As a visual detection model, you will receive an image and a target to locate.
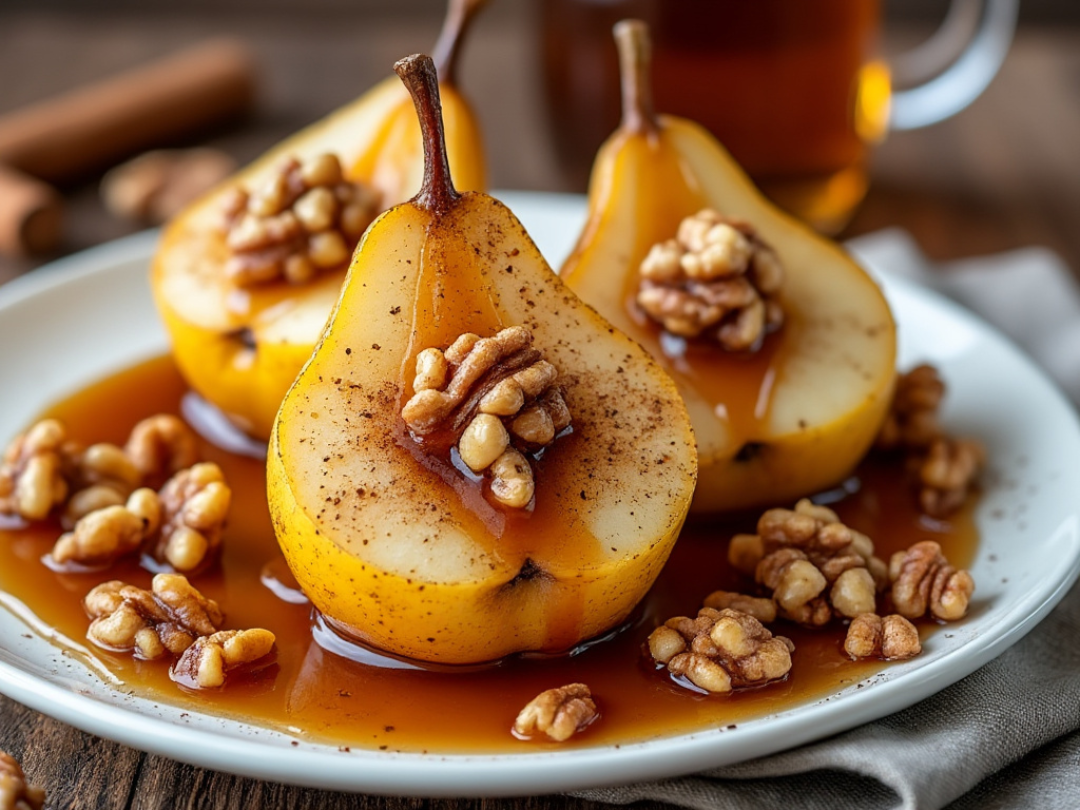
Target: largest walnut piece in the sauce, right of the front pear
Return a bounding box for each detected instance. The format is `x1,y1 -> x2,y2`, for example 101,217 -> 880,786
728,498 -> 889,626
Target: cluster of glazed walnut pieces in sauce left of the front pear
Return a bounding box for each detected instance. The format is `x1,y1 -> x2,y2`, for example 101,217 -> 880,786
0,414 -> 274,688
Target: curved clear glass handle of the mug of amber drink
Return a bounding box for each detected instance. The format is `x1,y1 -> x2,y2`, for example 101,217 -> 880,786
889,0 -> 1020,131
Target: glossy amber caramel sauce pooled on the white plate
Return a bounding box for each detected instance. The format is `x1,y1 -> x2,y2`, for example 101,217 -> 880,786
0,357 -> 977,753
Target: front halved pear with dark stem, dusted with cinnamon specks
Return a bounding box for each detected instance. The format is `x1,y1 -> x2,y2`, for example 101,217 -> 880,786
267,56 -> 697,664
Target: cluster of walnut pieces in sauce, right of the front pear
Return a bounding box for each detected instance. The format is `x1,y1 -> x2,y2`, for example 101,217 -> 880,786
630,499 -> 975,708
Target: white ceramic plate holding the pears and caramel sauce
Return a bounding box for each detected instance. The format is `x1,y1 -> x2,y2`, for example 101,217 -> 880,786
0,193 -> 1080,796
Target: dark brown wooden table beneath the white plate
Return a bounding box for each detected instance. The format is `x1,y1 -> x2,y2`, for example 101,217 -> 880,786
0,3 -> 1080,809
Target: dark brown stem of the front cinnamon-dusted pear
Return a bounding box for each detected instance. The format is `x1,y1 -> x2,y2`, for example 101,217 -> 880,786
394,53 -> 461,214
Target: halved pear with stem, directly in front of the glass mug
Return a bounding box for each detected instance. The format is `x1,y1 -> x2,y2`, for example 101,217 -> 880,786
559,21 -> 896,512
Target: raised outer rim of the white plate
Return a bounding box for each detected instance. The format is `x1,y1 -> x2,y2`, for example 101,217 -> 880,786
0,191 -> 1080,797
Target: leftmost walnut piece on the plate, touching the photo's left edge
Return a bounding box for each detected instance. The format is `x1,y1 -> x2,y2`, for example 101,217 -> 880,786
0,419 -> 69,521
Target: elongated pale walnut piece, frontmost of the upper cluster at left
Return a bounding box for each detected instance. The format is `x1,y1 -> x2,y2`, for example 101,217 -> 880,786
50,489 -> 161,566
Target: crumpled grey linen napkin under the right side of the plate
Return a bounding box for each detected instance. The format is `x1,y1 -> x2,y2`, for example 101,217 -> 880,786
575,230 -> 1080,810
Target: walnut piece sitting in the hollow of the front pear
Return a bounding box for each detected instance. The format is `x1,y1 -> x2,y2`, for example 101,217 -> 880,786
402,326 -> 570,509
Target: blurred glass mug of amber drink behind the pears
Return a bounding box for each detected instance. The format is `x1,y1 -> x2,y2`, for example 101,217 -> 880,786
540,0 -> 1018,233
